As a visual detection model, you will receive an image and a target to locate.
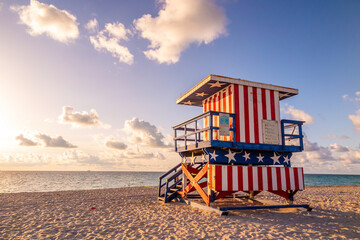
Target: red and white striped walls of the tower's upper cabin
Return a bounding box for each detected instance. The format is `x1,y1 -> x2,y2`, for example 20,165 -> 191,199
203,84 -> 281,144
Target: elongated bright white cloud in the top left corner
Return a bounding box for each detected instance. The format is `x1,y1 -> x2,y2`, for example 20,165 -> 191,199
10,0 -> 79,43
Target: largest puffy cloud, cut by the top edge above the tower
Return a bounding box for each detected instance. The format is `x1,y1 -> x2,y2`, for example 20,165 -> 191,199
134,0 -> 227,64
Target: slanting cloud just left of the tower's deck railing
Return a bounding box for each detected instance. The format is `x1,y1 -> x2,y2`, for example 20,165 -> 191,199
125,117 -> 172,148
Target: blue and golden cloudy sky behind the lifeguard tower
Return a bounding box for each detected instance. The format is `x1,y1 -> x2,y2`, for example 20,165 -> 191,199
0,0 -> 360,174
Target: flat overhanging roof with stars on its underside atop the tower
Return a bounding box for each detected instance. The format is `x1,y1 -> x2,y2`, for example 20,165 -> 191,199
176,74 -> 299,107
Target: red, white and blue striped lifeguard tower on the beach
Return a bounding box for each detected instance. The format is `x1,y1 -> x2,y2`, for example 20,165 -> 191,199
159,75 -> 309,214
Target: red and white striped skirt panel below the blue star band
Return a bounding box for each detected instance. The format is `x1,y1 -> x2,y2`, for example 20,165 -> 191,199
208,164 -> 305,191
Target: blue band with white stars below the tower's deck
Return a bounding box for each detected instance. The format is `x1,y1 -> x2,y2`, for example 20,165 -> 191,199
204,148 -> 292,166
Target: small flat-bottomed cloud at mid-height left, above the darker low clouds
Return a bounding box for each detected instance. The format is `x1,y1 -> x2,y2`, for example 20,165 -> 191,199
59,106 -> 110,128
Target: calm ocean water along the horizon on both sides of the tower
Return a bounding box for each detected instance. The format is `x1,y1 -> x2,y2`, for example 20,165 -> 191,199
0,171 -> 360,193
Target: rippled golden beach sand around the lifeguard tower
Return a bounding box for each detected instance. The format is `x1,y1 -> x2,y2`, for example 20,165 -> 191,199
0,186 -> 360,239
